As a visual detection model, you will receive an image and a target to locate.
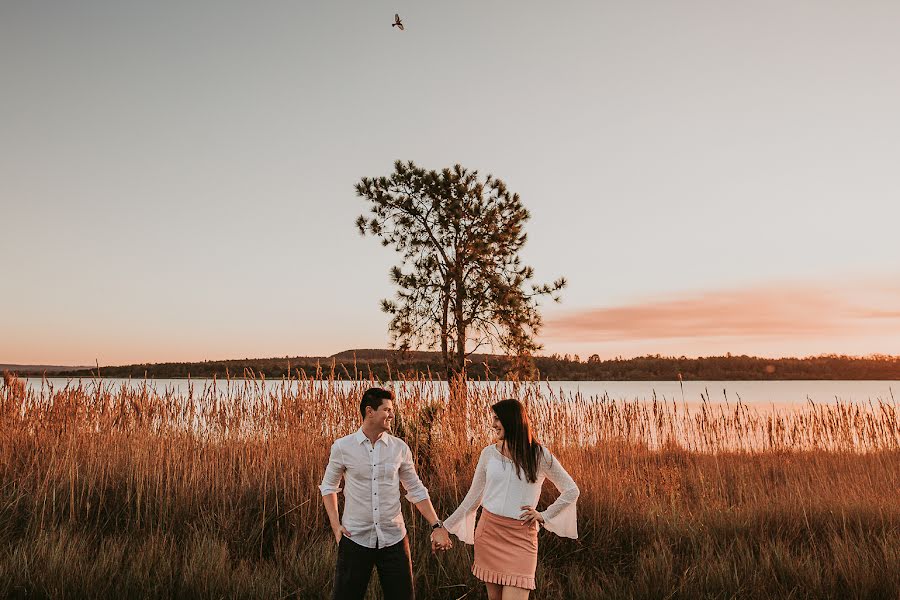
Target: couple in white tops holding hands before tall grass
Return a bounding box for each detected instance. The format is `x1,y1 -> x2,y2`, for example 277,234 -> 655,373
319,388 -> 579,600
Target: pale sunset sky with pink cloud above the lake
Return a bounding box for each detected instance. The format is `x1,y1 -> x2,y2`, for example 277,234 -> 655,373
0,0 -> 900,365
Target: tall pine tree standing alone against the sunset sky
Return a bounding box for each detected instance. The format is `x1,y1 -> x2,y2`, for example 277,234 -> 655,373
356,161 -> 566,379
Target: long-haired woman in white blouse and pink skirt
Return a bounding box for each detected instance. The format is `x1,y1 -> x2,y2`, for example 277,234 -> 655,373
444,400 -> 579,600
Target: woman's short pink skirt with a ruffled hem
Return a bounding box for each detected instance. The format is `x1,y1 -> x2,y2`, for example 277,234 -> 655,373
472,508 -> 538,590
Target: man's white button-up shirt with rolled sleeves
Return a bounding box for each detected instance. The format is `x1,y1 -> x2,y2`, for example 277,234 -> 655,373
319,429 -> 428,548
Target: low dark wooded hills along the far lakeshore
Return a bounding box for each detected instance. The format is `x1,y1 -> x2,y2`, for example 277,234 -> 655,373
11,349 -> 900,381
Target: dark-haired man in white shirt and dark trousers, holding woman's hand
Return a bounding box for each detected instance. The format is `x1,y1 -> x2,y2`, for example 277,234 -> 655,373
319,388 -> 452,600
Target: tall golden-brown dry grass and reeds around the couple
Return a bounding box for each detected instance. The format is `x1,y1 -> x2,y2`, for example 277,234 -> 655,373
0,378 -> 900,600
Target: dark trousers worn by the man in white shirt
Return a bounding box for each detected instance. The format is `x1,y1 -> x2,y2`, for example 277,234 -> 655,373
332,537 -> 416,600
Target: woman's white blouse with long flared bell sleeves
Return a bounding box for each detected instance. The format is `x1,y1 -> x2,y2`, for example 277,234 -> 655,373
444,444 -> 579,544
